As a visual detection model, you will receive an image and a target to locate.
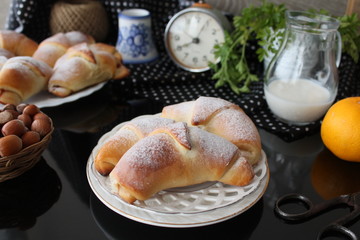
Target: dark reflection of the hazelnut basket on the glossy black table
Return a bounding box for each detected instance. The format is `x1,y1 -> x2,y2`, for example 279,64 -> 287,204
0,159 -> 61,230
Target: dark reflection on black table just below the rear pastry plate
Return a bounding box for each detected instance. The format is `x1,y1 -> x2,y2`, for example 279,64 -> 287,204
42,83 -> 163,133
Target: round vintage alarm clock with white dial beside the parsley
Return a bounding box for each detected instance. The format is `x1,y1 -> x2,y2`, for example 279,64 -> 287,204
164,2 -> 231,72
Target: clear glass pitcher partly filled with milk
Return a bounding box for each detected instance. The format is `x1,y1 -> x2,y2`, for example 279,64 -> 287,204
264,11 -> 341,125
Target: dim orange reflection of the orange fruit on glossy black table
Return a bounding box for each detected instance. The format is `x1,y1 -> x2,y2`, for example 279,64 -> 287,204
311,149 -> 360,200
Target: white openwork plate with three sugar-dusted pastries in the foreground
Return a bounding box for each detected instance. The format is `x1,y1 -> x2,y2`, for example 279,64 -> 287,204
87,97 -> 269,228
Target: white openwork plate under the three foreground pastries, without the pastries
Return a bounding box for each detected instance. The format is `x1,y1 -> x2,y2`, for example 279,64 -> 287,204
87,116 -> 269,227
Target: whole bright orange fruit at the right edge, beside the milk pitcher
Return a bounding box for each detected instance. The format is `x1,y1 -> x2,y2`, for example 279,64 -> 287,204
321,97 -> 360,162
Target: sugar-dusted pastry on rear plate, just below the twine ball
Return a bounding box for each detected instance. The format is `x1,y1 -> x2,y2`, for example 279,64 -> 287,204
33,31 -> 95,67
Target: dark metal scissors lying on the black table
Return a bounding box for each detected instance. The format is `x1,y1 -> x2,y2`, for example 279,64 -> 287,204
274,192 -> 360,240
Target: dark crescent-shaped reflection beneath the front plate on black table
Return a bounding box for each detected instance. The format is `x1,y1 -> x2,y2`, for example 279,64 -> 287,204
90,194 -> 263,240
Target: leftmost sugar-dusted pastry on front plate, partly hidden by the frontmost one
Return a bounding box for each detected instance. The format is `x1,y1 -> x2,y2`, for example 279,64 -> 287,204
94,117 -> 175,175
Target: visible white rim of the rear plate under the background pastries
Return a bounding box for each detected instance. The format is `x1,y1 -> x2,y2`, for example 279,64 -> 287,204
25,82 -> 106,108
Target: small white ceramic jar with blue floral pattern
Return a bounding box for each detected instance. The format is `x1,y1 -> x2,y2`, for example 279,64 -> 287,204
116,8 -> 158,64
